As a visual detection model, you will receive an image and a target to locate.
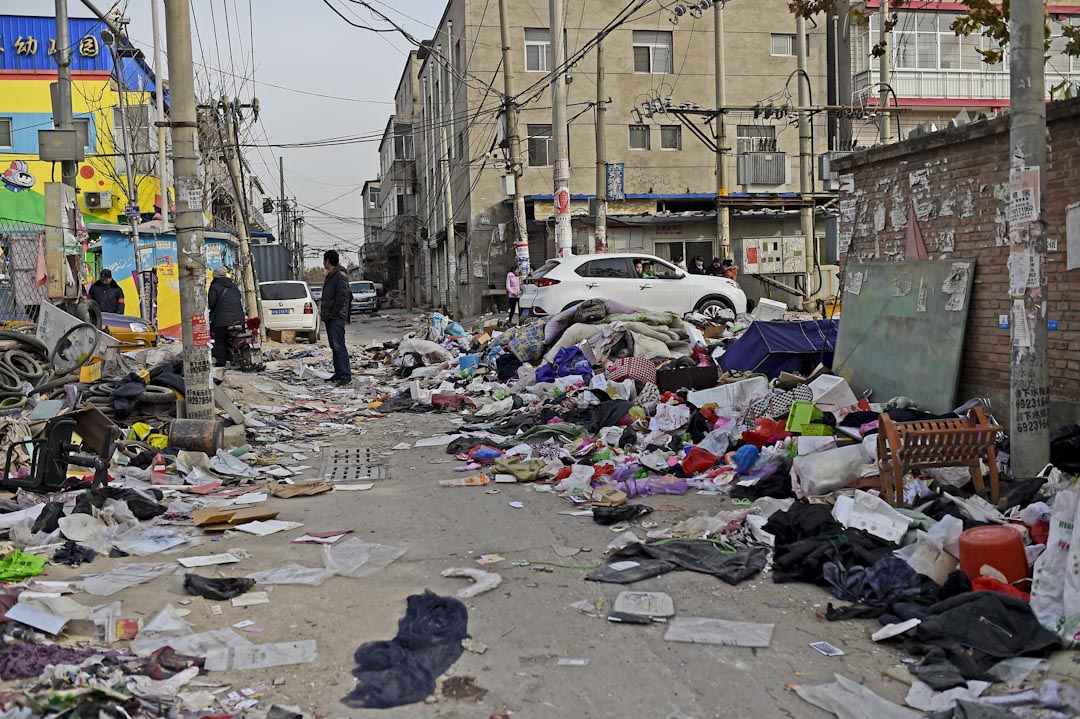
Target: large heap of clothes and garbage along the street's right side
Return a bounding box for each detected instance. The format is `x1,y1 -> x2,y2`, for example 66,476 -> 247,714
367,300 -> 1080,717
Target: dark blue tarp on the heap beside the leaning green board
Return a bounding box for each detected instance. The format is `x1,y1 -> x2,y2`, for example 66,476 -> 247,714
720,320 -> 840,379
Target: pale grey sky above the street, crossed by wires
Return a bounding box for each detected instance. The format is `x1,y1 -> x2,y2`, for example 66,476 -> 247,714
13,0 -> 445,264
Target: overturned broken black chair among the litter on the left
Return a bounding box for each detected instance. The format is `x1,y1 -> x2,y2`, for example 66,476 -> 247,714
0,415 -> 121,492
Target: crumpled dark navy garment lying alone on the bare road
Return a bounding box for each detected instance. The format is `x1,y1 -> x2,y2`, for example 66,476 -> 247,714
341,592 -> 469,709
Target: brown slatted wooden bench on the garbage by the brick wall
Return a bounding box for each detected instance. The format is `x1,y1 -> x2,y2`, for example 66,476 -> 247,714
878,407 -> 1001,506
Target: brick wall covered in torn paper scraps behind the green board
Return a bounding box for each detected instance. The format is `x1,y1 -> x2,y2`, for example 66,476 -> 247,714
837,99 -> 1080,430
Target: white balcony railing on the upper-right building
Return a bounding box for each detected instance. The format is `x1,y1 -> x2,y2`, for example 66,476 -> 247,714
852,67 -> 1080,105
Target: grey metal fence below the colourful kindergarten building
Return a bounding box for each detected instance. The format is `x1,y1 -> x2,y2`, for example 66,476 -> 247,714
0,219 -> 48,324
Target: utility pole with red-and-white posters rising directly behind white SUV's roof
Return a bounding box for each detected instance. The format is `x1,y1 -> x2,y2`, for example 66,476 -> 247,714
550,0 -> 573,257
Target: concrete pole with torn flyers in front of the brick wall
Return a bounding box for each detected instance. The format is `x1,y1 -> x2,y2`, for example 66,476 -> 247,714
1007,0 -> 1050,478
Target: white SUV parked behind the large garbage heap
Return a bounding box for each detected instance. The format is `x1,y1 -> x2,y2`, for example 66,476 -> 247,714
519,253 -> 748,316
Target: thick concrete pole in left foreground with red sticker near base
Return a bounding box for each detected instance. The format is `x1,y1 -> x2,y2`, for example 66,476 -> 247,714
165,0 -> 214,419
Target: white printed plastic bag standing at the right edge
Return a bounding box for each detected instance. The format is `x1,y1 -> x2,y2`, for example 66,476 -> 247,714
1031,485 -> 1080,642
